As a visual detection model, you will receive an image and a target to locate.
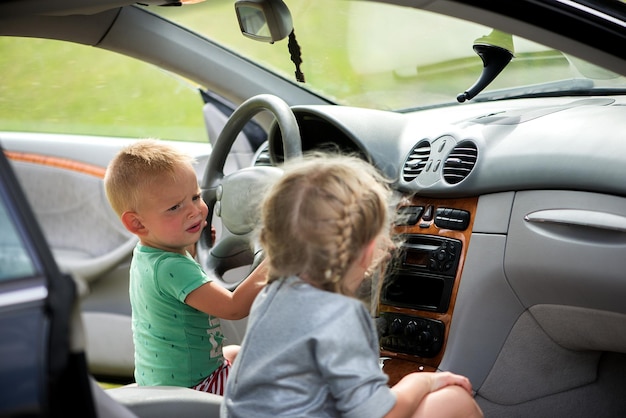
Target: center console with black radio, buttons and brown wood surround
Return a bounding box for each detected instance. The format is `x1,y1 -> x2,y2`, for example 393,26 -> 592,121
377,198 -> 477,385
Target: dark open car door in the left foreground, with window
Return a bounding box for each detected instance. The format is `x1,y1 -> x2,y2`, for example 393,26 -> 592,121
0,148 -> 95,417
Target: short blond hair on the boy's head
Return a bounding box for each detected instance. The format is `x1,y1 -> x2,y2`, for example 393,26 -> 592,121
104,139 -> 194,216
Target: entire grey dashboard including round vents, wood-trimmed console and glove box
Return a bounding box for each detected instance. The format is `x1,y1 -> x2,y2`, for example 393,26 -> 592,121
263,96 -> 626,392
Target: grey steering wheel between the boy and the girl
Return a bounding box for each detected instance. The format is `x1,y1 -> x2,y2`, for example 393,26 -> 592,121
196,94 -> 302,289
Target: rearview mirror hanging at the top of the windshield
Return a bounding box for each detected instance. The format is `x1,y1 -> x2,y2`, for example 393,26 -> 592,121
235,0 -> 293,43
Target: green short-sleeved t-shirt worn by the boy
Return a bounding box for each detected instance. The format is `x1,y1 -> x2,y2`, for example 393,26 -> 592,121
130,244 -> 224,387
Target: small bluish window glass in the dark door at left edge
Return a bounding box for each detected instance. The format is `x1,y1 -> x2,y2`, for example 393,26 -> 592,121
0,193 -> 35,281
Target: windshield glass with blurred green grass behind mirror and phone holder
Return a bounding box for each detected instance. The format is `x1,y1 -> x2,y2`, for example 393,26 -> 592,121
157,0 -> 626,110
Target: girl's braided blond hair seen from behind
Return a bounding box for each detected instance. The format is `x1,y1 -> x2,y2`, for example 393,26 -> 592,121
259,154 -> 390,294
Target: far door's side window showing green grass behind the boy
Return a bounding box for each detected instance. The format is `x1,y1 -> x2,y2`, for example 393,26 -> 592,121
0,37 -> 208,142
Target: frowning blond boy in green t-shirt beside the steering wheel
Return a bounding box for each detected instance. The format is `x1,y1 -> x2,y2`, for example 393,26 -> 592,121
104,140 -> 265,395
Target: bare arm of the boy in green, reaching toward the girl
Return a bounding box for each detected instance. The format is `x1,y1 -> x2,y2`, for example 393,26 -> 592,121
185,260 -> 267,319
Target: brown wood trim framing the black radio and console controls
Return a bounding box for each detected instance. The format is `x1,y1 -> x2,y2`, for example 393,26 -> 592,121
378,196 -> 478,386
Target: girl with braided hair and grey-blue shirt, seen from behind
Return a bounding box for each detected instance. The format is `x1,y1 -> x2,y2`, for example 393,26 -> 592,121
221,155 -> 482,418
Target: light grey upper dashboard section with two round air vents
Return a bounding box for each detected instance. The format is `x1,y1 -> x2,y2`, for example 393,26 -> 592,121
269,96 -> 626,197
